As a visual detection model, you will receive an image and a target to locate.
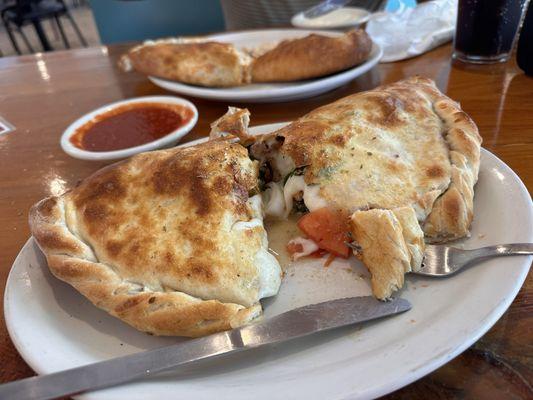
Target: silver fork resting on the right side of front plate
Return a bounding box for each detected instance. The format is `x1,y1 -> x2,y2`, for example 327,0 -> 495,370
412,243 -> 533,277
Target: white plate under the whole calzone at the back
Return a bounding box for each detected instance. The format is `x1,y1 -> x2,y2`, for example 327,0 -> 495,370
148,29 -> 383,103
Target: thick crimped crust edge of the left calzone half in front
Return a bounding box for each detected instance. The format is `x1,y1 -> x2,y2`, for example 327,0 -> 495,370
29,193 -> 261,337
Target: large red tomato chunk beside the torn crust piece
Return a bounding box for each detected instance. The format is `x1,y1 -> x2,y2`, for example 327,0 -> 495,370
298,208 -> 350,258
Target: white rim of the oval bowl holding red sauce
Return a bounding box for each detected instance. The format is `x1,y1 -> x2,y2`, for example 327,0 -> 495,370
61,96 -> 198,161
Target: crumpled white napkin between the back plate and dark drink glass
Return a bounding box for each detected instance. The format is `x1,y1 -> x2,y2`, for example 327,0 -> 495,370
366,0 -> 457,62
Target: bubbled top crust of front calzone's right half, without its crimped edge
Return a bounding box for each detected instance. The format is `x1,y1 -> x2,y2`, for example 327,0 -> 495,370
270,77 -> 462,221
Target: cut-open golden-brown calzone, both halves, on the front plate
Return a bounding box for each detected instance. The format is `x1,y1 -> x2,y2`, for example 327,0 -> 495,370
30,77 -> 481,336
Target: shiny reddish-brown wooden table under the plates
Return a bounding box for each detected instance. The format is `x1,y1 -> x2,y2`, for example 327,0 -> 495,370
0,45 -> 533,399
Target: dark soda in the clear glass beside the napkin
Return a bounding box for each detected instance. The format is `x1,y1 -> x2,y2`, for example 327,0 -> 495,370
454,0 -> 528,63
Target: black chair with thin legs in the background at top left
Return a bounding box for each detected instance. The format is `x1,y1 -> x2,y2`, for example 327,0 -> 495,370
1,0 -> 87,54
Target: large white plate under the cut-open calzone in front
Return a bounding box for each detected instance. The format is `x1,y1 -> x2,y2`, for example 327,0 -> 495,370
4,124 -> 533,400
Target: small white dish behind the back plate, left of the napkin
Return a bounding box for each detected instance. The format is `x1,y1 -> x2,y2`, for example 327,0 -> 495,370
291,7 -> 371,29
